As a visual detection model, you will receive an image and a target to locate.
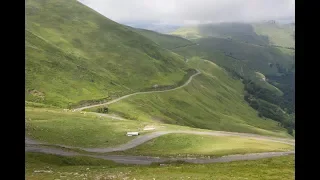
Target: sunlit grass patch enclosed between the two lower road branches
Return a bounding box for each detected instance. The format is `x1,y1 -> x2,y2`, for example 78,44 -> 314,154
121,134 -> 293,157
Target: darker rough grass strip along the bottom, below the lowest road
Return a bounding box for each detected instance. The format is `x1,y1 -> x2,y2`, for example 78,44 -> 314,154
26,153 -> 295,180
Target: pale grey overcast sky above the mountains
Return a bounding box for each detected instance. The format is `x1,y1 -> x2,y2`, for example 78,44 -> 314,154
79,0 -> 295,24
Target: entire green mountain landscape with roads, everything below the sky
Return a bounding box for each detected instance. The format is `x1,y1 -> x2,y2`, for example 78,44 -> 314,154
25,0 -> 295,179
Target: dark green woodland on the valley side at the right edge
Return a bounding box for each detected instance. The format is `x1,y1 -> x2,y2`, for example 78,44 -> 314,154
243,64 -> 295,135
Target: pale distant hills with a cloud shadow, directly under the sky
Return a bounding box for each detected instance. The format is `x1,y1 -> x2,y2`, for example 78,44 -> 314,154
170,22 -> 295,48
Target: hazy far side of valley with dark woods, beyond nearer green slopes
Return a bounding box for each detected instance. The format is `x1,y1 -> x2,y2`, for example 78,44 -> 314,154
172,22 -> 295,134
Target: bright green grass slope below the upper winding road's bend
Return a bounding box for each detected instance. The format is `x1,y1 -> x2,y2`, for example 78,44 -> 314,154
109,58 -> 288,137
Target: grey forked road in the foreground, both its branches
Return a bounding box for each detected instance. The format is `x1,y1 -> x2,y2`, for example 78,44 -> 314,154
25,131 -> 295,164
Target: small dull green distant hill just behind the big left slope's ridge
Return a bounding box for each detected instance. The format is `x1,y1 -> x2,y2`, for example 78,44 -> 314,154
130,29 -> 195,49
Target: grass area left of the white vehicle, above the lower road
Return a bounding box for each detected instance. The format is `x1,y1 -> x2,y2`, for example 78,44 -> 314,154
26,108 -> 152,147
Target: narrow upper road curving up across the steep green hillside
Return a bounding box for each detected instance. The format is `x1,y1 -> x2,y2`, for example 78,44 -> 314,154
73,70 -> 201,111
